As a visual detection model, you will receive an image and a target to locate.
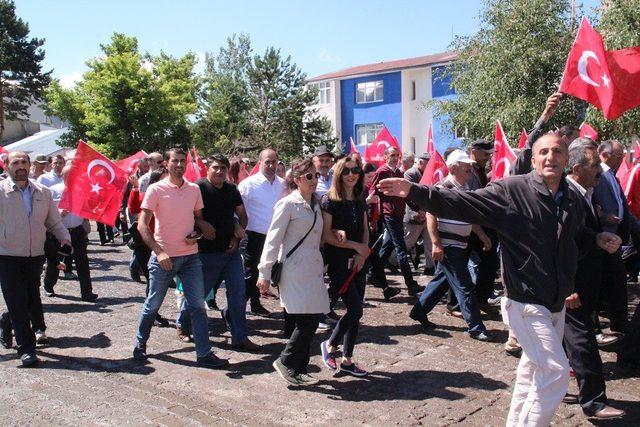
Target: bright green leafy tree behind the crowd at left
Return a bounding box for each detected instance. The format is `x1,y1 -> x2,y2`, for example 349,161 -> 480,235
45,33 -> 198,157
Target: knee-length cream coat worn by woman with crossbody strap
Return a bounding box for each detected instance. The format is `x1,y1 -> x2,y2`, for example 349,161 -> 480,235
258,191 -> 329,314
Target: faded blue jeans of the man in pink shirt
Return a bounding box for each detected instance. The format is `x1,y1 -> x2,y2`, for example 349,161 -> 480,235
136,254 -> 211,357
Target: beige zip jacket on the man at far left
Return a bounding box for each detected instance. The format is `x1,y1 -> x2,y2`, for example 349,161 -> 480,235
0,179 -> 71,257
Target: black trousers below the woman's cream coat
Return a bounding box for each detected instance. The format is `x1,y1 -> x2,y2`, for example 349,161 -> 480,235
280,313 -> 321,374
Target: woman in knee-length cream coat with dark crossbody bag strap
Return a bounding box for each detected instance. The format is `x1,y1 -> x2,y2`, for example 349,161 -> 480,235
258,160 -> 329,386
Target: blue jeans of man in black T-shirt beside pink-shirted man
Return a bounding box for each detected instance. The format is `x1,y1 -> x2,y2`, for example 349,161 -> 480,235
176,251 -> 249,344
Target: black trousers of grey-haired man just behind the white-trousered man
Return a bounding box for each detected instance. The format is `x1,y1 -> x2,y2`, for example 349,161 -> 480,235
564,305 -> 607,416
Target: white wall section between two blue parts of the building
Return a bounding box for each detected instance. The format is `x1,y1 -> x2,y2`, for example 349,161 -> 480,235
401,67 -> 433,154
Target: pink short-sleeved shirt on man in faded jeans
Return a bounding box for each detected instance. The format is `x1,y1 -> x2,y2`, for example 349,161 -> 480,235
141,177 -> 204,257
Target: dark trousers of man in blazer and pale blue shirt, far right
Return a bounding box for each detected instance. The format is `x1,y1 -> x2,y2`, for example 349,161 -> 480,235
600,250 -> 629,333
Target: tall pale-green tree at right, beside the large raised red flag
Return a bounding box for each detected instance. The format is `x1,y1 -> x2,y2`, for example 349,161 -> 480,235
430,0 -> 584,143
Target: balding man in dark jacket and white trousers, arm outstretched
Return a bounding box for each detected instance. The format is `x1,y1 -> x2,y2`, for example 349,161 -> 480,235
378,133 -> 621,425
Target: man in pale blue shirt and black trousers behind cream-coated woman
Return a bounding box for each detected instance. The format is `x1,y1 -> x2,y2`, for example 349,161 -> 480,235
238,148 -> 285,316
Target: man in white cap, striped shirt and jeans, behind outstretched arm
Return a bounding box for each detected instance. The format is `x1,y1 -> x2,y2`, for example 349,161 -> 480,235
409,150 -> 493,341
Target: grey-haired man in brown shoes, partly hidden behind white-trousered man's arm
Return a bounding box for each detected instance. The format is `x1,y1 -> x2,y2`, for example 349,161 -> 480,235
564,138 -> 624,419
